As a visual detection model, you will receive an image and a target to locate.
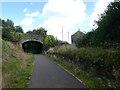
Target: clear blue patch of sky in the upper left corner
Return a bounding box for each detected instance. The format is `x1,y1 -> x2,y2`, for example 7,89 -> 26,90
2,2 -> 45,27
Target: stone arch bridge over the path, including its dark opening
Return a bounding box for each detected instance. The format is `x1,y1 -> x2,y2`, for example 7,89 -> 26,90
20,34 -> 44,53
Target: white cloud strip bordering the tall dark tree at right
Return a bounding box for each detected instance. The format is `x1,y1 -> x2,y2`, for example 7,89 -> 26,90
89,0 -> 114,28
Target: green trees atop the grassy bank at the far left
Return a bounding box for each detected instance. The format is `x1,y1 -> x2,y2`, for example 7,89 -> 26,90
1,19 -> 23,43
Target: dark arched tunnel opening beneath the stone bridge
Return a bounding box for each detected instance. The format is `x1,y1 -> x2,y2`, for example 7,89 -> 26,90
22,41 -> 43,54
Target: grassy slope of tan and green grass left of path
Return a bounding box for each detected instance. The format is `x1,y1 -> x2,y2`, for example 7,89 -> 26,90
2,40 -> 34,88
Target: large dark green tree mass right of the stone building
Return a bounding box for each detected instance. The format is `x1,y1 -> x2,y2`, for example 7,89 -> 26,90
77,1 -> 120,48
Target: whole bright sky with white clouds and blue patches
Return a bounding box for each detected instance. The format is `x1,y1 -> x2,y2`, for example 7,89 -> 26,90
0,0 -> 113,43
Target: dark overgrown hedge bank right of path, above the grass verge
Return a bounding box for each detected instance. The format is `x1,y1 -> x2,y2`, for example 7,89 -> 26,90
47,45 -> 120,87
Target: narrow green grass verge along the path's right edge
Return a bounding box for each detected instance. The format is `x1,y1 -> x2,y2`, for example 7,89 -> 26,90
46,55 -> 106,88
